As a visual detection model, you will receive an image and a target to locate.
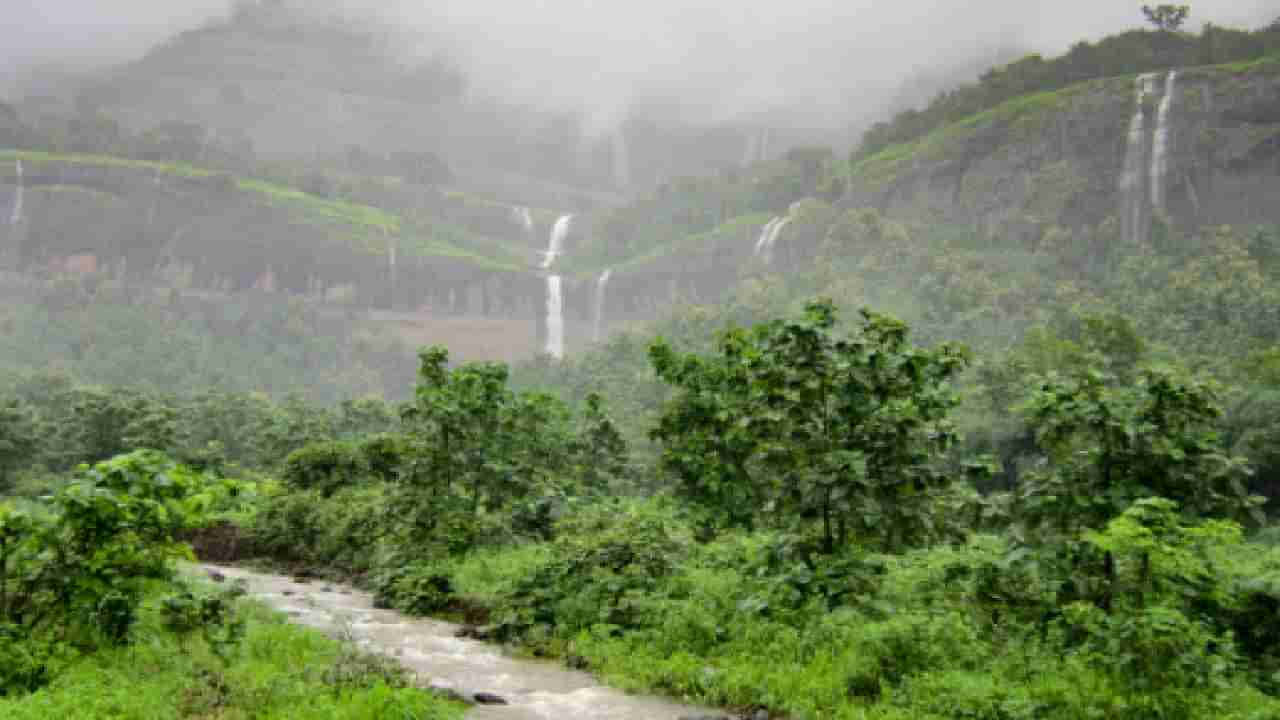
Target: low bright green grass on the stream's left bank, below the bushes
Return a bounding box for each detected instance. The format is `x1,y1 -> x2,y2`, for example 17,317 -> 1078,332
0,589 -> 463,720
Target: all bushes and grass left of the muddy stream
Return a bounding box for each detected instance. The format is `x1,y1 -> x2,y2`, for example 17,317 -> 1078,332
0,450 -> 461,719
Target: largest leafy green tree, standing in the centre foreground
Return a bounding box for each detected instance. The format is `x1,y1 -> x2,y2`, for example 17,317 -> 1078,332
650,301 -> 968,552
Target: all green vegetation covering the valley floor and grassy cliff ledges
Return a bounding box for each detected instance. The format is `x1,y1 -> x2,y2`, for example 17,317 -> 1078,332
0,13 -> 1280,720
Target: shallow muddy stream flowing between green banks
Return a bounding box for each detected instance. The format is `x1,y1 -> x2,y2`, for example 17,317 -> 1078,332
202,565 -> 727,720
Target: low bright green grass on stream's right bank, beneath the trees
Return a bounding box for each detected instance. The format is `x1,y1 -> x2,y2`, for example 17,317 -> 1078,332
432,537 -> 1280,720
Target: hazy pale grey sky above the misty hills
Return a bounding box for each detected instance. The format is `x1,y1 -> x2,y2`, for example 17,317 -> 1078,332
0,0 -> 1280,124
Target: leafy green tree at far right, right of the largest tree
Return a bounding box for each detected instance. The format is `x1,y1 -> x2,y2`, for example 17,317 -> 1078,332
1018,364 -> 1262,536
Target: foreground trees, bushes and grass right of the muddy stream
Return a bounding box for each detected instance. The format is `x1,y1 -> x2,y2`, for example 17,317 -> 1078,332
160,293 -> 1280,719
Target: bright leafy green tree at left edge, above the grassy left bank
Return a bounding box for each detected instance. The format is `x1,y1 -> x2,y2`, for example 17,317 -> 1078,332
0,451 -> 215,666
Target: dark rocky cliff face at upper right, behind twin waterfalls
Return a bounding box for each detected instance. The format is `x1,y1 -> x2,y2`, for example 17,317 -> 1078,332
844,58 -> 1280,238
